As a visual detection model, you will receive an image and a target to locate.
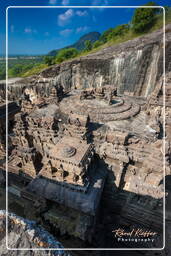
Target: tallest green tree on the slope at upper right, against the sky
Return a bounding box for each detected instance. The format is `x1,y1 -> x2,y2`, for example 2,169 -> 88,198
132,2 -> 159,33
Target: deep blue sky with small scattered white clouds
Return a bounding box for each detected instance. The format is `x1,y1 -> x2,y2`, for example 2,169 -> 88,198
0,0 -> 171,55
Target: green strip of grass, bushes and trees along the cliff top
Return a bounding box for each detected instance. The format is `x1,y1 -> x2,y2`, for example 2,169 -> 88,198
9,2 -> 171,77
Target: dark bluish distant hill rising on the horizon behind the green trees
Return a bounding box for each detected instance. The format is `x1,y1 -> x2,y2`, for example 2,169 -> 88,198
48,32 -> 100,56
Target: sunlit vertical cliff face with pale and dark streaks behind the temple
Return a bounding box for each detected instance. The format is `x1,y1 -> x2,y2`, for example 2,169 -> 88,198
41,24 -> 171,97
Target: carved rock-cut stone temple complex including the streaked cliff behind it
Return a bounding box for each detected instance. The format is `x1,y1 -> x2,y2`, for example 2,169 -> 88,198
0,25 -> 171,255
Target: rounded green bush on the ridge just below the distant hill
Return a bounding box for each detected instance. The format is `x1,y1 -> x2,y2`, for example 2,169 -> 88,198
55,48 -> 78,63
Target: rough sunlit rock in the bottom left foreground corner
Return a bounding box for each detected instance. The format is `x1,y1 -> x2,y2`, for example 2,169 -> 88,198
0,211 -> 69,256
